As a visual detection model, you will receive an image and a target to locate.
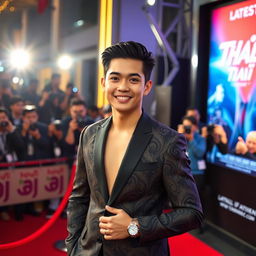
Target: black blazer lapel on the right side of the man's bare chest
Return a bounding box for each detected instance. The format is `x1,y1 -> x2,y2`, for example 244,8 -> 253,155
108,113 -> 152,205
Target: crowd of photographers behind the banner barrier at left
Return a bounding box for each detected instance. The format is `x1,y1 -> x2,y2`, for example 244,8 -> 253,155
0,73 -> 111,220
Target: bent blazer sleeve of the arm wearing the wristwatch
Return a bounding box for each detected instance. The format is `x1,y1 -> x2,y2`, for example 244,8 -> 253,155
138,134 -> 203,243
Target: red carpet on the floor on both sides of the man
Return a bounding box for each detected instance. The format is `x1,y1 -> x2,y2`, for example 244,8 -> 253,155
0,216 -> 222,256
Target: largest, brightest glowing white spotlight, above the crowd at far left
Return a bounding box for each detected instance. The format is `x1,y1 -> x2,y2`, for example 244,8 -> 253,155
10,49 -> 30,69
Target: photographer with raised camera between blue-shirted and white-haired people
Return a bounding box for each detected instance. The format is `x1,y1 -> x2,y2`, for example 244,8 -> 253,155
202,124 -> 228,154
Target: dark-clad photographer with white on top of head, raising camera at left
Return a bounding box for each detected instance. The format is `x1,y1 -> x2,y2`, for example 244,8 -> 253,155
20,105 -> 52,160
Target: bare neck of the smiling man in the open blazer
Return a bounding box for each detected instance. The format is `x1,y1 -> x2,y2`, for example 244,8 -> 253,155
112,110 -> 142,131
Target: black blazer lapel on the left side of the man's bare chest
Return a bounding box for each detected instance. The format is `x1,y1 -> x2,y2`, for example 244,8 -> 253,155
94,117 -> 112,203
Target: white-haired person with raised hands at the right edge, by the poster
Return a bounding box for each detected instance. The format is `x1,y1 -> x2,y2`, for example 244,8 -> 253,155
235,131 -> 256,160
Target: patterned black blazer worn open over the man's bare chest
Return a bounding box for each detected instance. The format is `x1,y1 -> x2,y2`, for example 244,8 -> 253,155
66,113 -> 202,256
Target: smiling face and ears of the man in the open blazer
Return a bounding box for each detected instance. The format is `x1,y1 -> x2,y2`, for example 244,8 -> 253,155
102,58 -> 152,113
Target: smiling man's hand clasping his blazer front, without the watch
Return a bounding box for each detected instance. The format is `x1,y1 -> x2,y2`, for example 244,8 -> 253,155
99,205 -> 132,240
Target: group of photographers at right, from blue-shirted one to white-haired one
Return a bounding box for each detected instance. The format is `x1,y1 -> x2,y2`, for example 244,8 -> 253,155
177,107 -> 256,231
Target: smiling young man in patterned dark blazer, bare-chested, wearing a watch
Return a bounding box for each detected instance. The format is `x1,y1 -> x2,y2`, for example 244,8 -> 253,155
66,42 -> 202,256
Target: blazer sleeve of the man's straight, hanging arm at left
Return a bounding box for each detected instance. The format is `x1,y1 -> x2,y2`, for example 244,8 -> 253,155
65,129 -> 90,255
